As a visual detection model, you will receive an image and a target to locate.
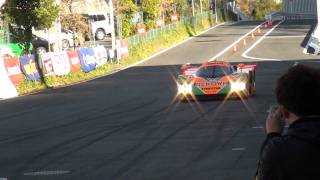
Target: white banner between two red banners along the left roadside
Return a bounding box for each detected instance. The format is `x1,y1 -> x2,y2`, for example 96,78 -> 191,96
51,51 -> 71,76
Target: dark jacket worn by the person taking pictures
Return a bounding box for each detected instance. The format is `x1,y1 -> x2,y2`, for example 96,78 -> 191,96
256,117 -> 320,180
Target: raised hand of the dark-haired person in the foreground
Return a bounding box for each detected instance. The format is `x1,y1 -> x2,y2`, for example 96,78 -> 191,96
266,106 -> 285,134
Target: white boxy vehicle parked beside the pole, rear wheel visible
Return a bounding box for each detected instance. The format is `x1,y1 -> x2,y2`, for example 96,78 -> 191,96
82,13 -> 111,40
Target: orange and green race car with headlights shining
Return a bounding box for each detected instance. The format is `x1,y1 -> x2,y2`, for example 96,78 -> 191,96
177,61 -> 256,99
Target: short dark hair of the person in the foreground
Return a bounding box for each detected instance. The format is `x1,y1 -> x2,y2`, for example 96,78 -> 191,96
275,64 -> 320,117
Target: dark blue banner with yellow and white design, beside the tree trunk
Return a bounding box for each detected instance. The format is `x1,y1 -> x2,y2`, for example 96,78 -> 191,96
20,54 -> 40,81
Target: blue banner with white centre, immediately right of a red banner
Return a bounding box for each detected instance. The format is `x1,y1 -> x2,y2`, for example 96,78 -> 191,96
78,48 -> 97,72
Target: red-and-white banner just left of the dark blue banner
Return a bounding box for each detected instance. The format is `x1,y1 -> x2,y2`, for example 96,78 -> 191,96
3,57 -> 24,85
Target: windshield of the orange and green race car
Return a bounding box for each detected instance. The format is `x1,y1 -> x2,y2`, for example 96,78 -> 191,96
196,66 -> 232,78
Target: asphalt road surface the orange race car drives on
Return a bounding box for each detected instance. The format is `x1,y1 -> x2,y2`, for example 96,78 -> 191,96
0,22 -> 320,180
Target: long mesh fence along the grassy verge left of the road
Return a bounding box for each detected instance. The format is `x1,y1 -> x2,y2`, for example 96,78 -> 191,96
127,12 -> 211,45
